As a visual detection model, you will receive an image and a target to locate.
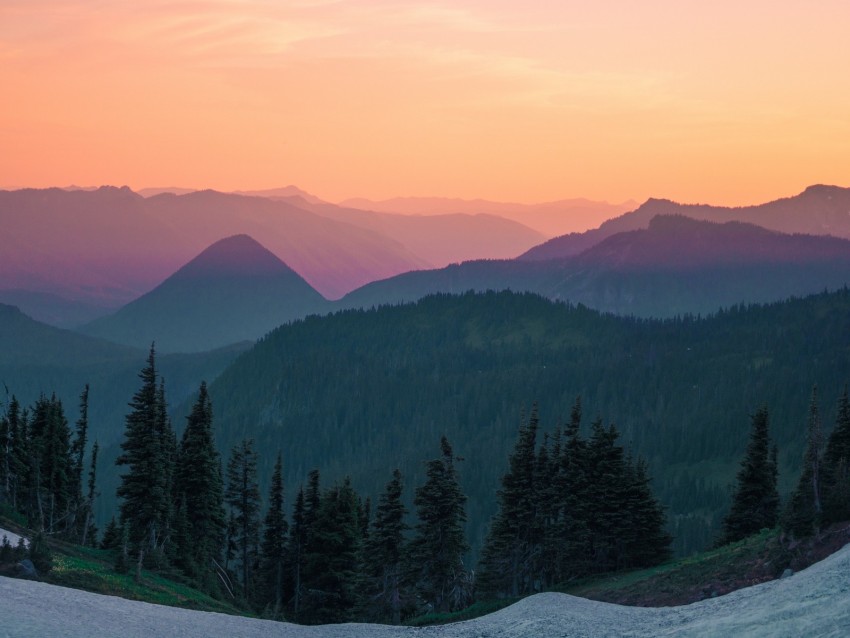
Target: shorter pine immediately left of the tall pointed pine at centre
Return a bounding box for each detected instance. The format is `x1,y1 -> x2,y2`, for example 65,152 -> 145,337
363,469 -> 408,625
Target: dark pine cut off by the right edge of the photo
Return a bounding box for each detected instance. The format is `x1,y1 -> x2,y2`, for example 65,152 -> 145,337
823,386 -> 850,525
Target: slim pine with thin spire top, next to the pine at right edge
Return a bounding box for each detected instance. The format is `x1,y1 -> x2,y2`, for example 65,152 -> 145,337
783,387 -> 822,537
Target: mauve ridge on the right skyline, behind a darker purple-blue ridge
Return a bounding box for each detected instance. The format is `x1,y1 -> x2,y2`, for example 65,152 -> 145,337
519,185 -> 850,260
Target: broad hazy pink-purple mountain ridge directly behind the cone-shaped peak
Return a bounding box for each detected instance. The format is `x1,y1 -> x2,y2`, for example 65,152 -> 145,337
0,187 -> 428,303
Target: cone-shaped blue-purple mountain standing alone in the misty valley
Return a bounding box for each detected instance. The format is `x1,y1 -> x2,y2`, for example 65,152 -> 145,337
80,235 -> 327,353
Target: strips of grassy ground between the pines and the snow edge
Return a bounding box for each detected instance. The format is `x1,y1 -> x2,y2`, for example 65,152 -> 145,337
0,516 -> 850,626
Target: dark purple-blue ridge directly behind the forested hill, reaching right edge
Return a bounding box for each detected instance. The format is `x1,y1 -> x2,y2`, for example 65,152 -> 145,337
339,216 -> 850,317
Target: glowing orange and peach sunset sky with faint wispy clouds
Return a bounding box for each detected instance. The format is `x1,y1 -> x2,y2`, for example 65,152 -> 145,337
0,0 -> 850,204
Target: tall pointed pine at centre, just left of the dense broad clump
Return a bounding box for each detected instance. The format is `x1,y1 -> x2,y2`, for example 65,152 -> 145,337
411,436 -> 471,612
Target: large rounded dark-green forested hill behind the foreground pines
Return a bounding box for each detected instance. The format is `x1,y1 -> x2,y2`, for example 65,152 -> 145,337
205,290 -> 850,553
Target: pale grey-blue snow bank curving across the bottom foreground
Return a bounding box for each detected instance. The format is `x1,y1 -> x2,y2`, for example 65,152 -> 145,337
0,546 -> 850,638
